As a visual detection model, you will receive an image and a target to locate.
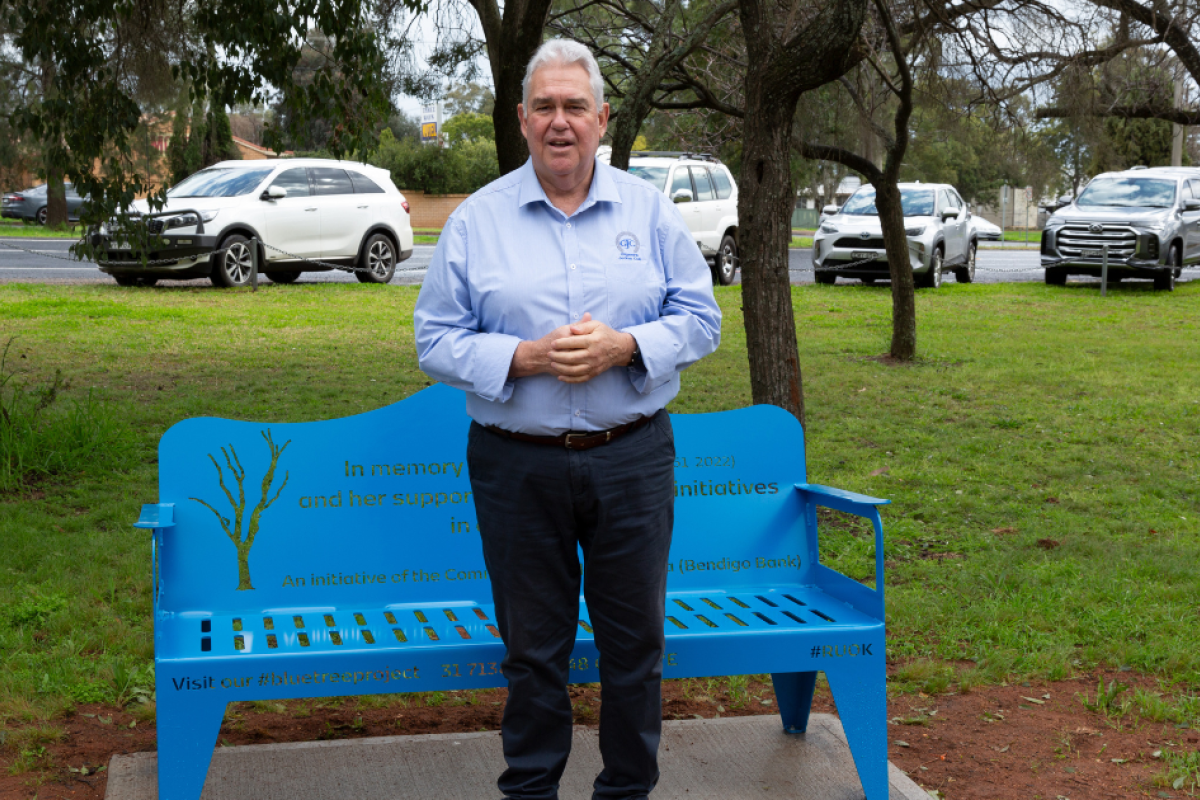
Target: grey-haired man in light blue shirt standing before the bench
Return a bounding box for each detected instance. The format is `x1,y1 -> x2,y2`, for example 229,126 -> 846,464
414,40 -> 720,800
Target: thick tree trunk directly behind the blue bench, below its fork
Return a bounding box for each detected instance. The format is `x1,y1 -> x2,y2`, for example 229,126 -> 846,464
738,85 -> 804,425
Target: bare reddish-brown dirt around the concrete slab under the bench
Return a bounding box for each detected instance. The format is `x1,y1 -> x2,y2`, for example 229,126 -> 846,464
0,673 -> 1200,800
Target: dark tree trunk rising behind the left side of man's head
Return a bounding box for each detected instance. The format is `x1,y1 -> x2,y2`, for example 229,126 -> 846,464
470,0 -> 551,175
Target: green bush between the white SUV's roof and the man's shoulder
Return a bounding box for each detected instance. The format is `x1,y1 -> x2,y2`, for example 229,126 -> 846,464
368,130 -> 500,194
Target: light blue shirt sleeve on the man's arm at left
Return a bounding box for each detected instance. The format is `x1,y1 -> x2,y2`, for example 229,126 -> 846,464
413,217 -> 521,403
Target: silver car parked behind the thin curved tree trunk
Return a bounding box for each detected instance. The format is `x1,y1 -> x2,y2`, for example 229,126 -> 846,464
812,184 -> 978,289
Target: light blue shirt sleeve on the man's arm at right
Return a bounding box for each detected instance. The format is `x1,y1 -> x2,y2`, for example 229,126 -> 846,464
622,207 -> 721,395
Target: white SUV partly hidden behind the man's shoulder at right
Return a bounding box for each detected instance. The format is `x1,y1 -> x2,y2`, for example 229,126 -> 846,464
598,146 -> 738,285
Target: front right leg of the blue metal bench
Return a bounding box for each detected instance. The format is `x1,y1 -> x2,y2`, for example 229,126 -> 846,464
826,662 -> 888,800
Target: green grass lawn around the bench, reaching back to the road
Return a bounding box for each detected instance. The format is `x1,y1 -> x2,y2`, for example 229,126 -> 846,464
0,282 -> 1200,729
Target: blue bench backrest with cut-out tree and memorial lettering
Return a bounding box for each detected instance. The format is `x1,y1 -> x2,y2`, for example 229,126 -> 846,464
158,385 -> 816,613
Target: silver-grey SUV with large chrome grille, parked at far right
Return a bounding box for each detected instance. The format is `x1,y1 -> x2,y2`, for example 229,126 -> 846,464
1042,167 -> 1200,291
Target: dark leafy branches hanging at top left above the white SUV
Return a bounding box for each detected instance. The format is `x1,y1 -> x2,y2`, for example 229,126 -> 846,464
0,0 -> 405,241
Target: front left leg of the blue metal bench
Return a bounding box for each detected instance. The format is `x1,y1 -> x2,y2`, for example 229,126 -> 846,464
155,680 -> 226,800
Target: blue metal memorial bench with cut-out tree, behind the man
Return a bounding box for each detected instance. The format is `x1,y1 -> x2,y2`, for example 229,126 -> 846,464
137,386 -> 888,800
